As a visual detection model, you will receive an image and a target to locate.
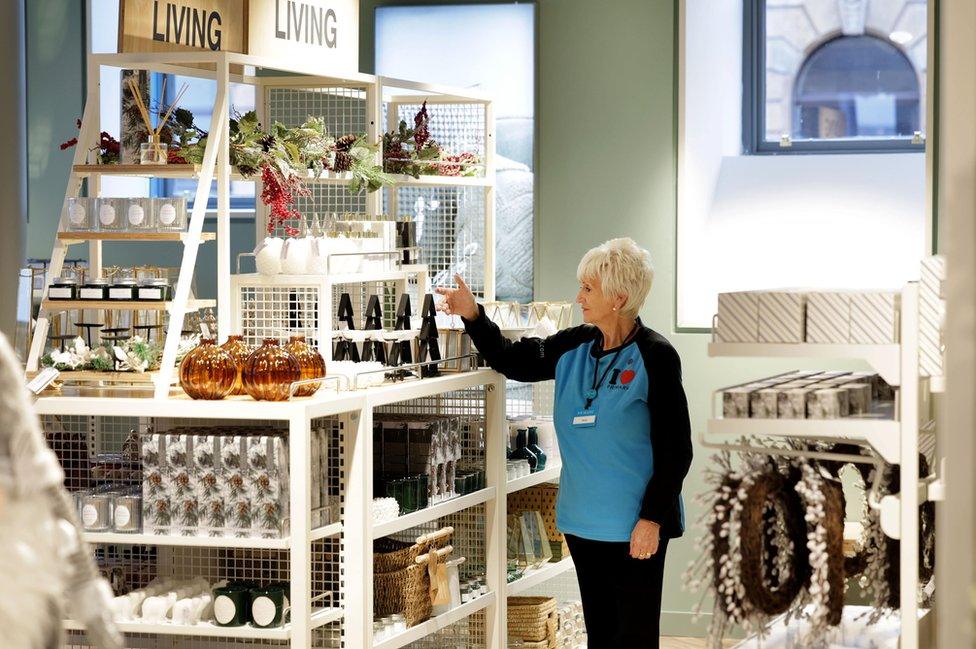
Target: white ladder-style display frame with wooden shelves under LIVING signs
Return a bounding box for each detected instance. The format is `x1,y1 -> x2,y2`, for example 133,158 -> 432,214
27,51 -> 495,398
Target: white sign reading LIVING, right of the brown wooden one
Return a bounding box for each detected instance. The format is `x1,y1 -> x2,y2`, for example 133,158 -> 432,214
248,0 -> 359,72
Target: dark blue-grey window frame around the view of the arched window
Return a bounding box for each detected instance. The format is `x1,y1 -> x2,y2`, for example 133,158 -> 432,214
742,0 -> 932,155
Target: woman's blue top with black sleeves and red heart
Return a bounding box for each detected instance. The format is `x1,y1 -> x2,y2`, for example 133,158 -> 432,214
464,306 -> 692,542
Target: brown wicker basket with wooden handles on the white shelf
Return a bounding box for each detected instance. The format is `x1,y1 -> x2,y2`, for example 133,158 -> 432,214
373,535 -> 451,627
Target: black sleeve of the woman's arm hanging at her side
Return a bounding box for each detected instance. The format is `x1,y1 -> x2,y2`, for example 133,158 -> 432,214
640,342 -> 692,536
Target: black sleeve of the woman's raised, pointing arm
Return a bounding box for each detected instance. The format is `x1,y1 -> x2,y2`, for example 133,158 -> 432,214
462,304 -> 588,382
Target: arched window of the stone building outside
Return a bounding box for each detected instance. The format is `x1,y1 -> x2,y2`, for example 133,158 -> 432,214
791,36 -> 921,140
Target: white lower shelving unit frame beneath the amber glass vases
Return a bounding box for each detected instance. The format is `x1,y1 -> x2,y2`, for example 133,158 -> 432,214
36,370 -> 507,648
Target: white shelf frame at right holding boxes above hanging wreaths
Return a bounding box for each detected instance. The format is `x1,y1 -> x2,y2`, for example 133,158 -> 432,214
701,282 -> 941,649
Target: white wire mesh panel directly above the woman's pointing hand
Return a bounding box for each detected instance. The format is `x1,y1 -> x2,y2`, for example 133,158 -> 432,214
383,186 -> 487,297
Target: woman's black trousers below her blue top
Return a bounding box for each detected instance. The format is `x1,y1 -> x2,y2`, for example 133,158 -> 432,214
566,534 -> 668,649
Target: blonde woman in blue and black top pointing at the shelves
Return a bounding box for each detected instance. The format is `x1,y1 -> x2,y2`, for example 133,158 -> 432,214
438,239 -> 692,649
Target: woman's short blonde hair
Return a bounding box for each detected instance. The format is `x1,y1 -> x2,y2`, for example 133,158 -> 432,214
576,237 -> 654,317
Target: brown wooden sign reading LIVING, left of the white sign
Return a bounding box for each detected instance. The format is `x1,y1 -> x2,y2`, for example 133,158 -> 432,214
119,0 -> 248,54
